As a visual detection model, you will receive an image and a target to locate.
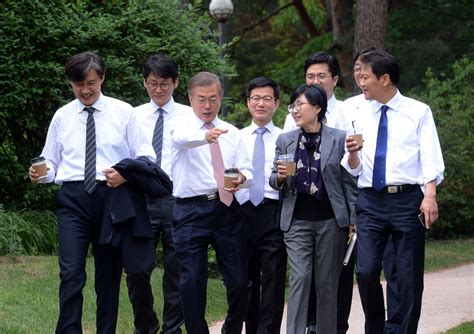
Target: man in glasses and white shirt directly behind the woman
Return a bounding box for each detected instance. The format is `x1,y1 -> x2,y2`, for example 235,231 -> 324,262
283,52 -> 346,132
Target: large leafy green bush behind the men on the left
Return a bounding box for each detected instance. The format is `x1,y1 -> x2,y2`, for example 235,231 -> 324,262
0,0 -> 234,208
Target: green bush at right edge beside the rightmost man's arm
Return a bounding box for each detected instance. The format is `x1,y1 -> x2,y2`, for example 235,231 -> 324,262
421,57 -> 474,238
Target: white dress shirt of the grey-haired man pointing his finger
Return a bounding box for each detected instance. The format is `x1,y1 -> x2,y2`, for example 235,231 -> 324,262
171,112 -> 252,198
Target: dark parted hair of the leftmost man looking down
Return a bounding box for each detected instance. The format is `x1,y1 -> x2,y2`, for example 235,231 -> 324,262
64,51 -> 106,82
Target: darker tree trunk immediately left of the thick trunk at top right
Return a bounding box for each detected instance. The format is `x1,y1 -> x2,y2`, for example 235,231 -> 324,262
330,0 -> 354,90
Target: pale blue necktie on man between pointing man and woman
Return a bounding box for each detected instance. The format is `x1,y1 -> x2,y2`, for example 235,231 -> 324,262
250,128 -> 267,206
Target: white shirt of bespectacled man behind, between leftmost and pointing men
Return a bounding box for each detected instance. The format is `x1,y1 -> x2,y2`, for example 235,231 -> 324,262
135,97 -> 193,176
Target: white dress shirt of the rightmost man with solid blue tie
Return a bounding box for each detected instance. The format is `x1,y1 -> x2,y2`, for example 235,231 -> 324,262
341,91 -> 444,188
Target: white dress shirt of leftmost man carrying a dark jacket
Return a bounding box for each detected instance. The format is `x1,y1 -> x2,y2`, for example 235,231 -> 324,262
41,94 -> 154,184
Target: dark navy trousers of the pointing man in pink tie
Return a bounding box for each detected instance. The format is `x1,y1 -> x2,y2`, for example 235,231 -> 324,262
173,199 -> 249,334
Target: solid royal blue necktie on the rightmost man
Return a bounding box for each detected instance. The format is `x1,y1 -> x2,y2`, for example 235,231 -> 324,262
372,105 -> 388,191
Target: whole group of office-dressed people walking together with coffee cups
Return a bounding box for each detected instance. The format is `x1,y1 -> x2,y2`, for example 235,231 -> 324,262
29,48 -> 444,334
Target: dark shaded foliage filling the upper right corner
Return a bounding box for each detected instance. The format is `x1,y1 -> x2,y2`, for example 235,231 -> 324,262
386,0 -> 474,90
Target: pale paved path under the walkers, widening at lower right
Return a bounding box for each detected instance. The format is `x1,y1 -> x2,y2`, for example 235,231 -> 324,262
209,263 -> 474,334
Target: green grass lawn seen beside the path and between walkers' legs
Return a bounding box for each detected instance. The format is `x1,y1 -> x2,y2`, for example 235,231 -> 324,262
0,239 -> 474,334
